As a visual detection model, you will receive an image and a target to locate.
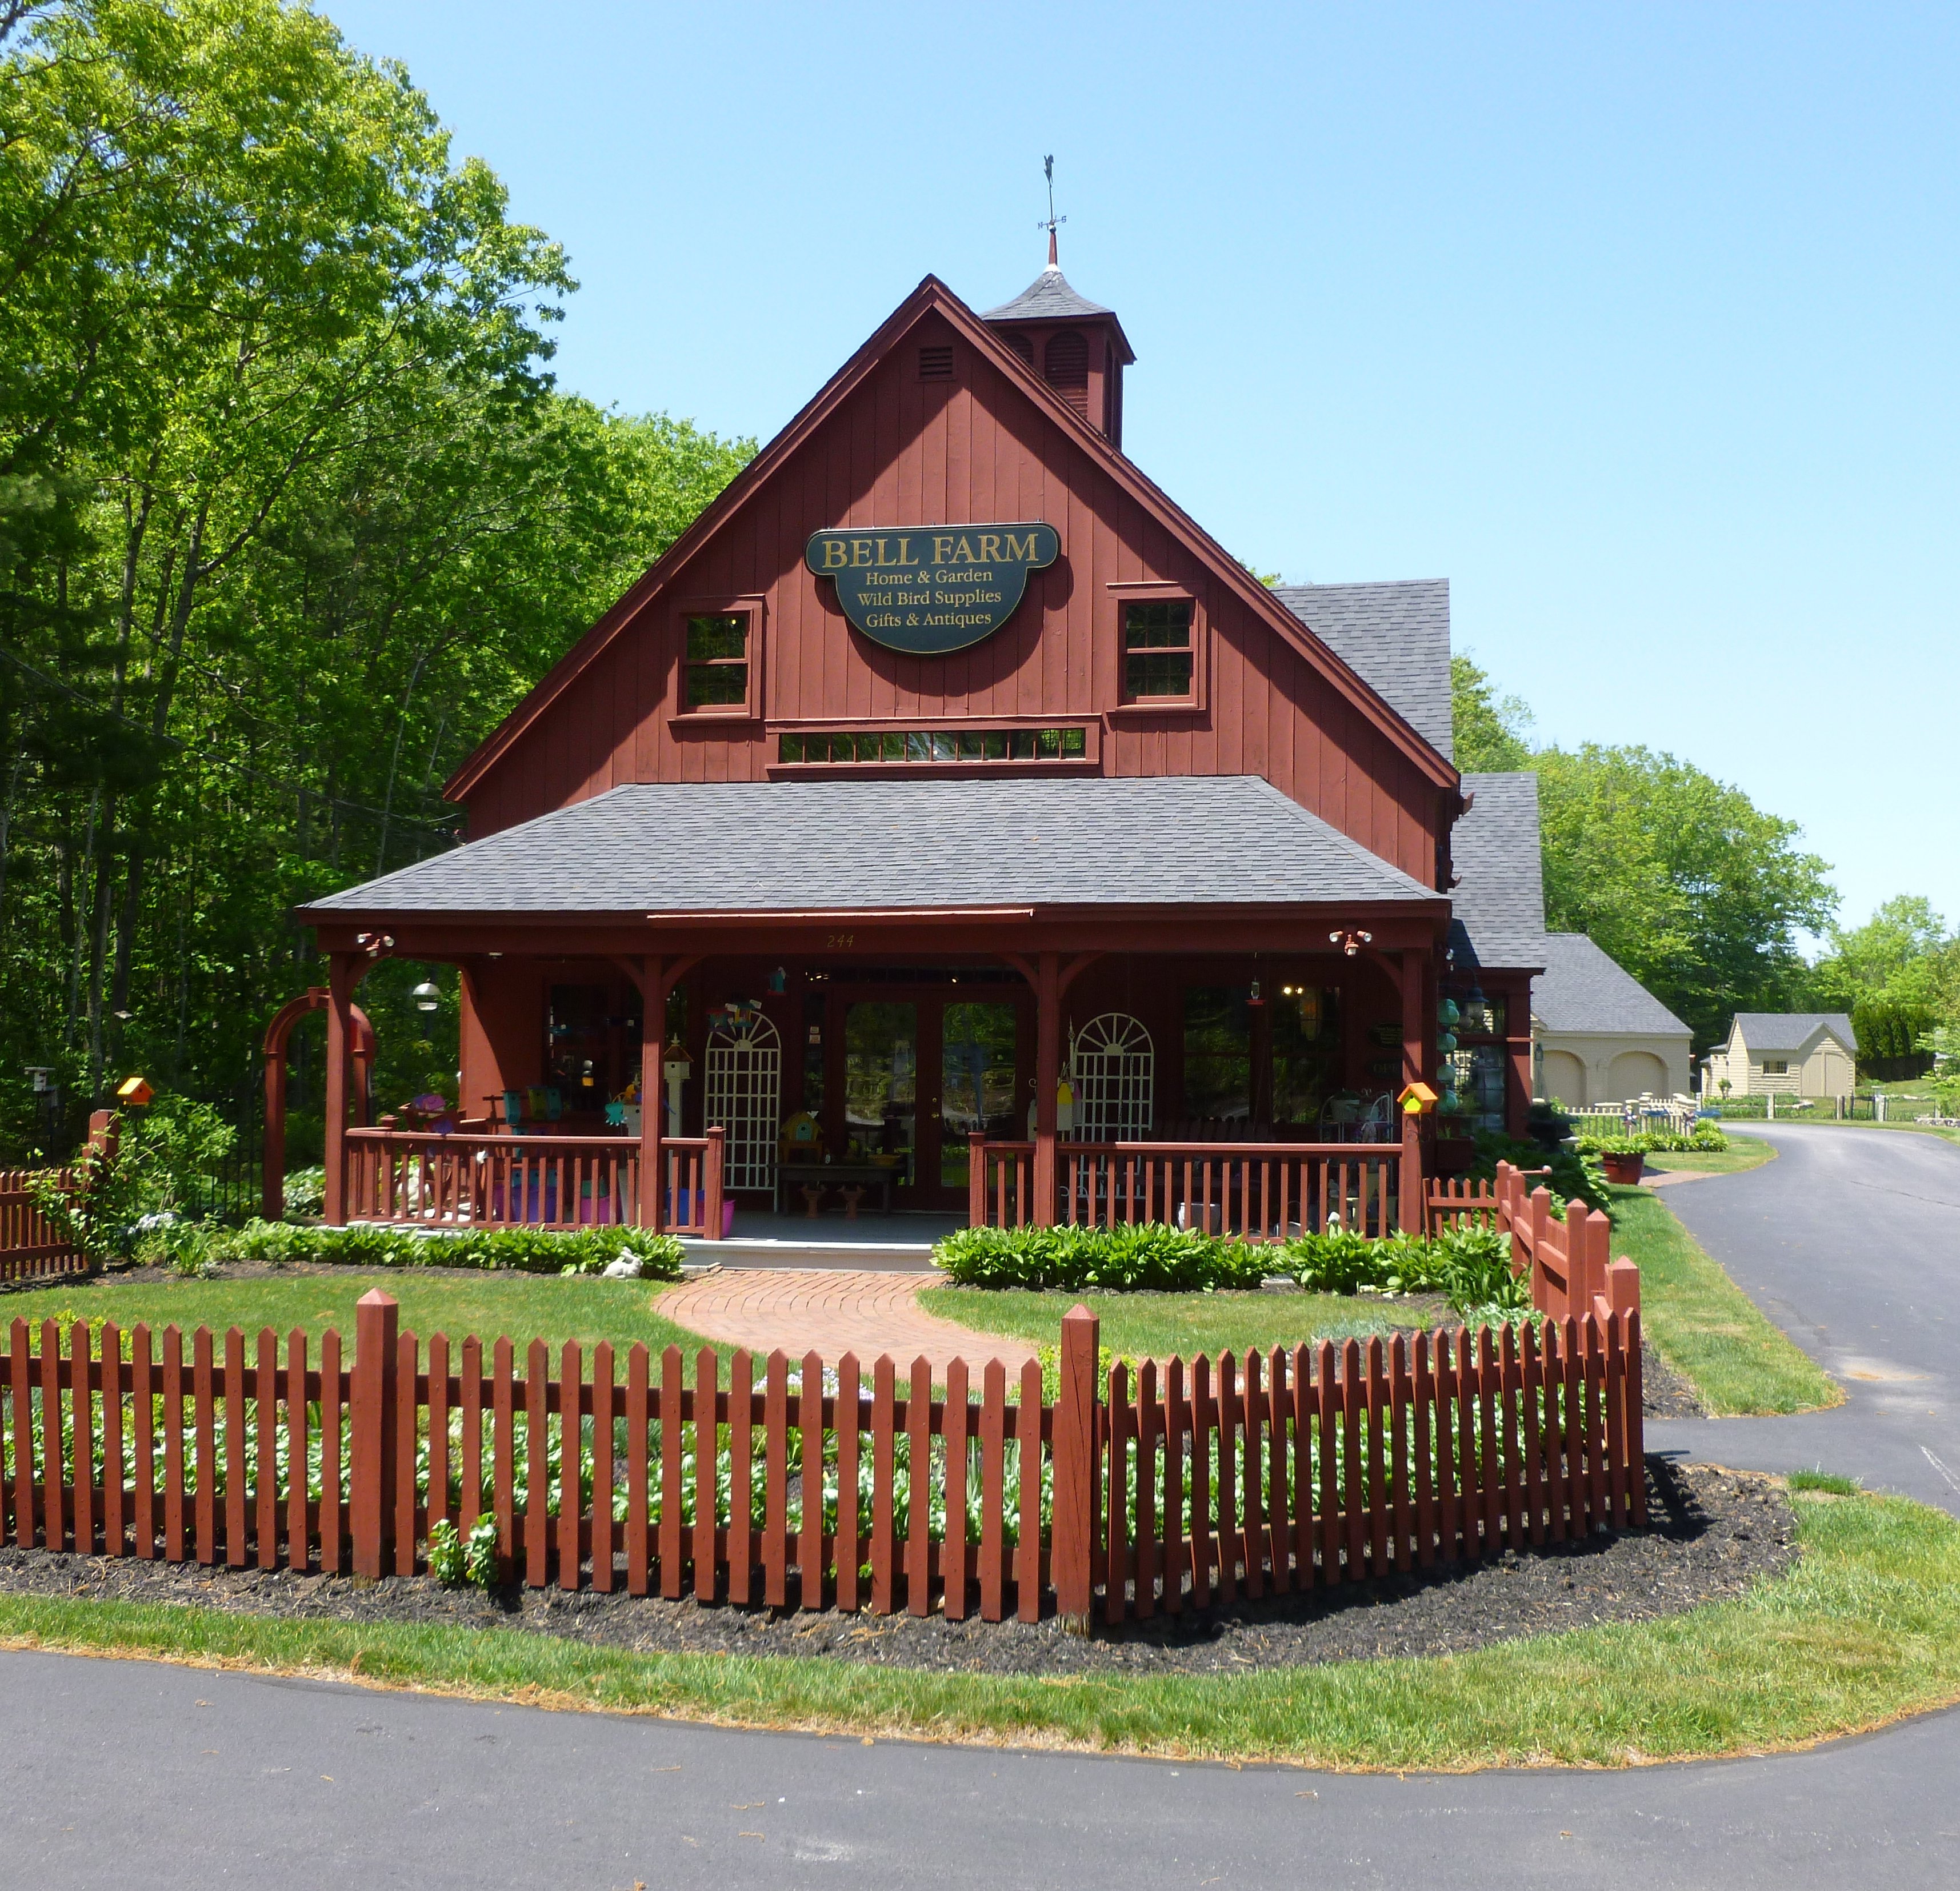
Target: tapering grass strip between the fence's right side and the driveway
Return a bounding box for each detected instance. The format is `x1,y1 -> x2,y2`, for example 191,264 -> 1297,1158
1607,1188 -> 1845,1417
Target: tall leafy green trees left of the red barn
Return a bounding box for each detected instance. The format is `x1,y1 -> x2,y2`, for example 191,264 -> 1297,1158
0,0 -> 753,1140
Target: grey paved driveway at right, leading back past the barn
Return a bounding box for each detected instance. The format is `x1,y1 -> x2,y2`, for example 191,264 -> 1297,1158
1646,1123 -> 1960,1511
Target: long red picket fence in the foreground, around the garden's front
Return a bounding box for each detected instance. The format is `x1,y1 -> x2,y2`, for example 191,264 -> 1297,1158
0,1293 -> 1645,1621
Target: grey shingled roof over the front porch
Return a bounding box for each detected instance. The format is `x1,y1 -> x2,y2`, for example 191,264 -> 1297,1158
300,776 -> 1441,921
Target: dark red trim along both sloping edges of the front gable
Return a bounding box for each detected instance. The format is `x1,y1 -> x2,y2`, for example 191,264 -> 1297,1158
443,277 -> 1456,802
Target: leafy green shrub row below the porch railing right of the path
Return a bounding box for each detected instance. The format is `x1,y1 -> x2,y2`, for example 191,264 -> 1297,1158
933,1223 -> 1529,1313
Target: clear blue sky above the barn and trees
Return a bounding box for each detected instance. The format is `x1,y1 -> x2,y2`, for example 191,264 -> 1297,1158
323,0 -> 1960,944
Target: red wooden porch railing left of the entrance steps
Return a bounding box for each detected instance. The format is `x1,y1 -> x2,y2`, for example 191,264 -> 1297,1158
347,1129 -> 723,1240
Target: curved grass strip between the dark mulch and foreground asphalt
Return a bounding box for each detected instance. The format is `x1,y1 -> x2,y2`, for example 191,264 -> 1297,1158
0,1493 -> 1960,1769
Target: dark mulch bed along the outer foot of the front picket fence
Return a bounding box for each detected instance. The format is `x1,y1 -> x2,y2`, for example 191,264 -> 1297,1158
0,1458 -> 1797,1673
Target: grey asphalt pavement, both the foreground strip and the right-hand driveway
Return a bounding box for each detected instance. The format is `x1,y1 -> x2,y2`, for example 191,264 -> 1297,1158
11,1125 -> 1960,1891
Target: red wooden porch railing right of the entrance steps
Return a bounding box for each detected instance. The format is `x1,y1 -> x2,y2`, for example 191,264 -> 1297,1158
968,1139 -> 1401,1240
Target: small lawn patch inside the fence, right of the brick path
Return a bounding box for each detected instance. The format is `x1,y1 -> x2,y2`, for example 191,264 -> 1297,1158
919,1288 -> 1427,1360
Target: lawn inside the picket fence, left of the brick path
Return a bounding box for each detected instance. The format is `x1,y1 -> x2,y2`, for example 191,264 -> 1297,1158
0,1268 -> 702,1360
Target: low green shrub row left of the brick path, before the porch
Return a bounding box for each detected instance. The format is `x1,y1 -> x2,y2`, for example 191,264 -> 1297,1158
198,1221 -> 686,1280
